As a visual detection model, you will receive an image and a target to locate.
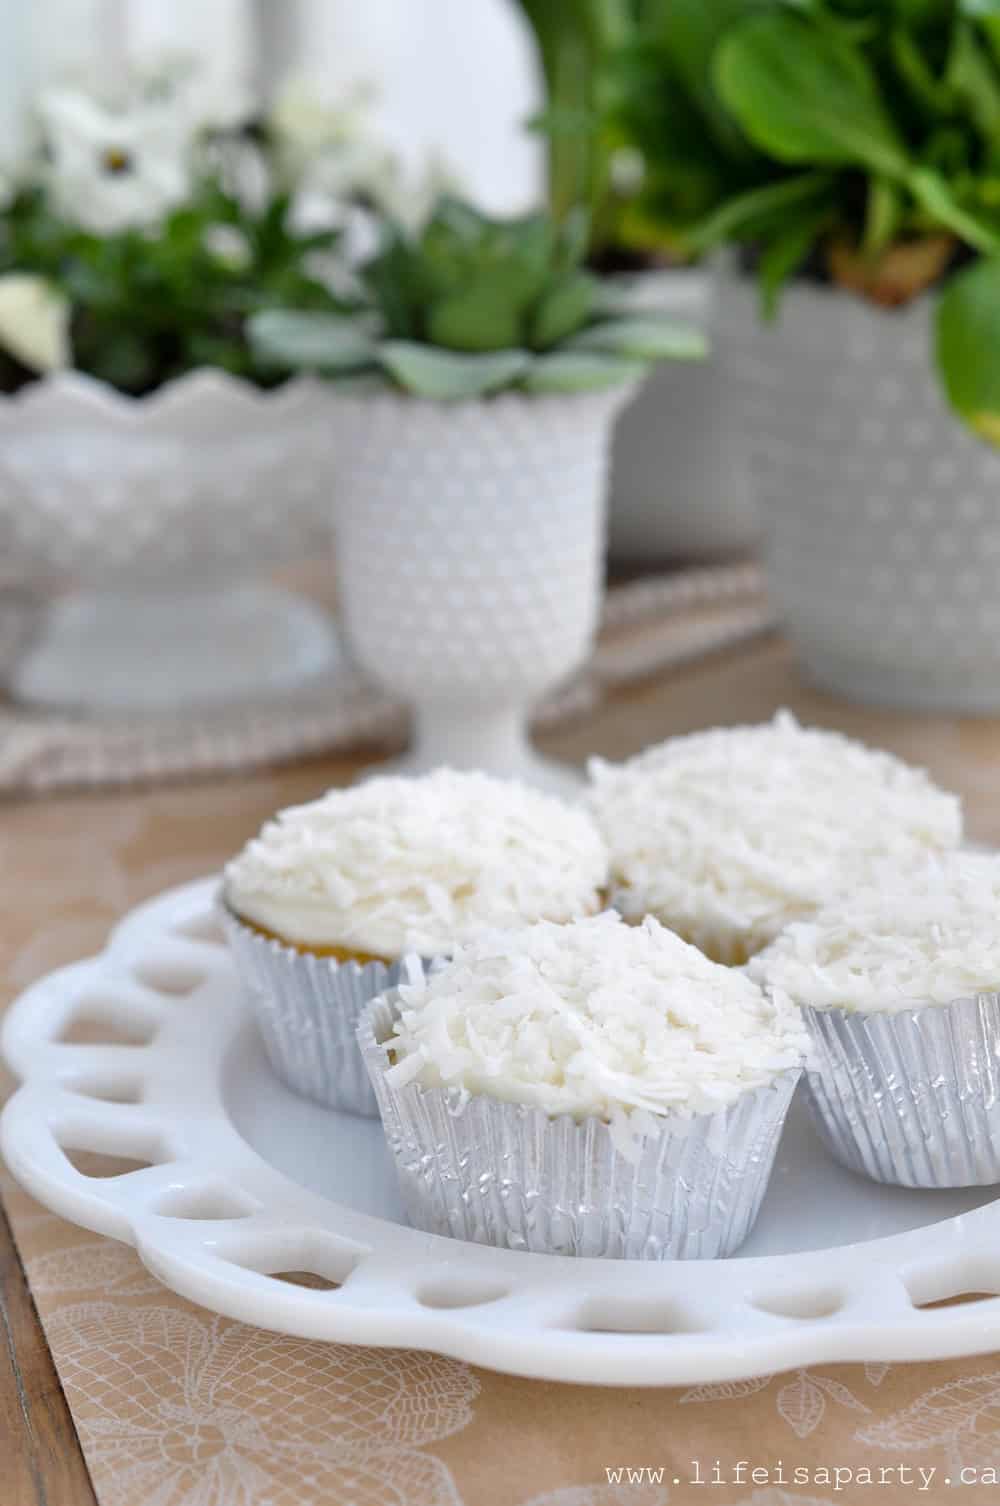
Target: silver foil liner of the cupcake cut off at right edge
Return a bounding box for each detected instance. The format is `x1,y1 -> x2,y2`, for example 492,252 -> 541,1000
803,994 -> 1000,1187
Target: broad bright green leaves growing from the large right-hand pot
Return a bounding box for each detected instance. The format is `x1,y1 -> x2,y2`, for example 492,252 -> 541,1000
578,0 -> 1000,443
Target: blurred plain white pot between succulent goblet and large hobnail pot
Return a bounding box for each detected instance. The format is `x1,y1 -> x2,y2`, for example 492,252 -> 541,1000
610,268 -> 759,562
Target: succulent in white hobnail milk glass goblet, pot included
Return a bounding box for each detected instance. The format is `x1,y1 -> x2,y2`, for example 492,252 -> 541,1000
252,199 -> 703,785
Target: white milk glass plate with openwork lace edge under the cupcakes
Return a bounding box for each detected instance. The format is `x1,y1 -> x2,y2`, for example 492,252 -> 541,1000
0,880 -> 1000,1386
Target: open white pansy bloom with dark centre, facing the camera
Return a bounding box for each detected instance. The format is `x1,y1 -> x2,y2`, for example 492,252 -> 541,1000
39,89 -> 193,235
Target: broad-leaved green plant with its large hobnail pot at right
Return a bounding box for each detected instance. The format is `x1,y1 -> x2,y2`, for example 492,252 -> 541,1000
626,0 -> 1000,711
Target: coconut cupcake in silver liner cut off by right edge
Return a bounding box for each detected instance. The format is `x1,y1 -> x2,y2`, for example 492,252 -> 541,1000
750,852 -> 1000,1187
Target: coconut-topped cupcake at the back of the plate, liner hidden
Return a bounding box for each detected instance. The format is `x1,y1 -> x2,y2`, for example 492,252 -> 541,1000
589,712 -> 962,965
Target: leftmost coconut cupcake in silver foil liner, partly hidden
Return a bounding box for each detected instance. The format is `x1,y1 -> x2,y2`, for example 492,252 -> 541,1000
221,770 -> 607,1114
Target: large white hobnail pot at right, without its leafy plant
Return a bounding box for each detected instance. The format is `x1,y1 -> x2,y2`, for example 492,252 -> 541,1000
724,280 -> 1000,712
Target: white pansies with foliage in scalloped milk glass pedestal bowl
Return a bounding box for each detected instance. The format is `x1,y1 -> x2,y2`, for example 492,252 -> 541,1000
0,68 -> 406,709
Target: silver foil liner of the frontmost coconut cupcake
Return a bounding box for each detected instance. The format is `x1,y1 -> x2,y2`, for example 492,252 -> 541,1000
358,994 -> 800,1261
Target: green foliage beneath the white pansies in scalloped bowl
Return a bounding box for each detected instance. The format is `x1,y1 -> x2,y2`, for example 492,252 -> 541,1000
0,178 -> 339,395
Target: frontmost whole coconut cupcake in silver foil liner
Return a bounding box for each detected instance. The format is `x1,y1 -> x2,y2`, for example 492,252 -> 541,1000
358,913 -> 806,1261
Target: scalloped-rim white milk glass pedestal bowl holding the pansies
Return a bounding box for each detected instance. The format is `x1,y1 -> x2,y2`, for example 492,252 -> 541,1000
0,370 -> 336,711
